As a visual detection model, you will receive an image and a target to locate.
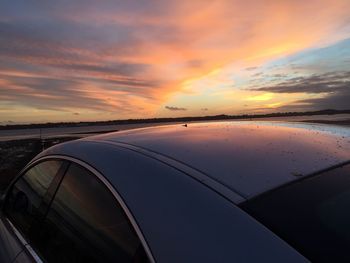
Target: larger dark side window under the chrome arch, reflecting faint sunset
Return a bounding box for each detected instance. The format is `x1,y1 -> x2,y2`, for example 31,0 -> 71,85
35,164 -> 148,263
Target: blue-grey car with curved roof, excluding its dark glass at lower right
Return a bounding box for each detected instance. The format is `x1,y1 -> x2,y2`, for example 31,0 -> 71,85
0,121 -> 350,263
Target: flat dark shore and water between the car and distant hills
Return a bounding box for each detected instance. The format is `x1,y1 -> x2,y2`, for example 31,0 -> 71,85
0,114 -> 350,191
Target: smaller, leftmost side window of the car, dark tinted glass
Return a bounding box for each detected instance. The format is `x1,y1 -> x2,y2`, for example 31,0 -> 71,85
5,160 -> 62,241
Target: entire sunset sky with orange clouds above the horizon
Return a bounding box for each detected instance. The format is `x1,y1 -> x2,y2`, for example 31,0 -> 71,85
0,0 -> 350,124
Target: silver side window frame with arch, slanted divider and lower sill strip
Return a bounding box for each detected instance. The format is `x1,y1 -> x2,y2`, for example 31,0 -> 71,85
1,155 -> 156,263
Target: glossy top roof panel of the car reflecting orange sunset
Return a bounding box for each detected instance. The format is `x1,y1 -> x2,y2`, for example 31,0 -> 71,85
83,121 -> 350,199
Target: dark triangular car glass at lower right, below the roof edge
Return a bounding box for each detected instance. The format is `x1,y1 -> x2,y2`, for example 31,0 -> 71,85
241,164 -> 350,262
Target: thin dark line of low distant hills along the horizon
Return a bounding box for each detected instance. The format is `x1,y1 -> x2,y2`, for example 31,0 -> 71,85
0,109 -> 350,130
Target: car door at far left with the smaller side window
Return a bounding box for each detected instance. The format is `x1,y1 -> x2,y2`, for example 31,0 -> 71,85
0,160 -> 64,262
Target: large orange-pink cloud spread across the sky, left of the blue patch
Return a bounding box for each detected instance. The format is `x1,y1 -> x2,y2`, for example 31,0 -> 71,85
0,0 -> 350,120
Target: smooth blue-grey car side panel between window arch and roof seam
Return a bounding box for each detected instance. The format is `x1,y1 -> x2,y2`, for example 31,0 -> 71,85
35,135 -> 306,263
